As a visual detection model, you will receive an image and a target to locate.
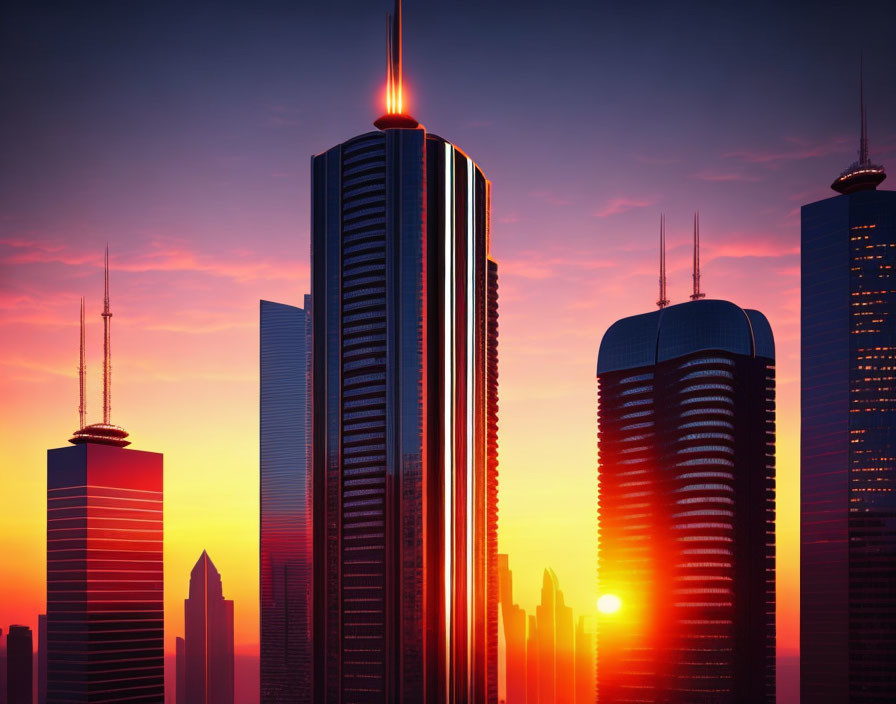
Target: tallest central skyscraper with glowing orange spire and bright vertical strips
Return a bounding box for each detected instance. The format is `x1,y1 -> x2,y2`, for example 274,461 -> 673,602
311,3 -> 498,704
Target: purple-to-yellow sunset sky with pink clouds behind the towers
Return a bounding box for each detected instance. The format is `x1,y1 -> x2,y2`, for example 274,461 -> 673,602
0,0 -> 896,688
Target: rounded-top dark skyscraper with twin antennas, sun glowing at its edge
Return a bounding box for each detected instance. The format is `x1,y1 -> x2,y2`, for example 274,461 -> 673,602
597,223 -> 775,704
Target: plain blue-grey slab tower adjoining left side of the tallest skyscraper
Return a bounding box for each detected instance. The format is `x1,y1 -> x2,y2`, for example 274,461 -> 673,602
259,296 -> 311,704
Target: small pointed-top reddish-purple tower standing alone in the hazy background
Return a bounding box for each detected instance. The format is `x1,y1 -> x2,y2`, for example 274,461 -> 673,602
177,550 -> 233,704
